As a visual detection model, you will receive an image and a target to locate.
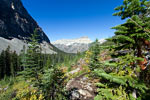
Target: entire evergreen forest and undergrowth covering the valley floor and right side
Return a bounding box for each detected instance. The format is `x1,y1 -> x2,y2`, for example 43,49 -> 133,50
0,0 -> 150,100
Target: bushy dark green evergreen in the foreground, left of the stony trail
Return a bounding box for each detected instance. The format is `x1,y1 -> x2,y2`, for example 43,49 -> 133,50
41,66 -> 68,100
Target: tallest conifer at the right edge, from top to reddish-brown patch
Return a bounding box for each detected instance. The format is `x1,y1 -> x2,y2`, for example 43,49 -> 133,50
109,0 -> 150,70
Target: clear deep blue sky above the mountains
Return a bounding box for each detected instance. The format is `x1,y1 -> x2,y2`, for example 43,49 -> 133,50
22,0 -> 123,41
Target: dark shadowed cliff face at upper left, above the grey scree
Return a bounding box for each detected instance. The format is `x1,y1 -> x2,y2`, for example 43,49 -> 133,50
0,0 -> 50,43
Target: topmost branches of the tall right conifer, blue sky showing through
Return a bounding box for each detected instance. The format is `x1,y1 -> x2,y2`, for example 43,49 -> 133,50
113,0 -> 150,19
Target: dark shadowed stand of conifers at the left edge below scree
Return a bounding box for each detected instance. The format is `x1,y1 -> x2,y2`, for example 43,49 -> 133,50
0,46 -> 21,79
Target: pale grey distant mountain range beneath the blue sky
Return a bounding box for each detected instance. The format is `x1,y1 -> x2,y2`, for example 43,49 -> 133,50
52,37 -> 106,53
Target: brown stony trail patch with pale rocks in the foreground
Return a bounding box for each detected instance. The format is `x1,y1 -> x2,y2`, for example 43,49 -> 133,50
66,73 -> 96,100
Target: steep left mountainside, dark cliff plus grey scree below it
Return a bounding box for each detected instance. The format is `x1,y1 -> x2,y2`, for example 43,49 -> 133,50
0,0 -> 56,53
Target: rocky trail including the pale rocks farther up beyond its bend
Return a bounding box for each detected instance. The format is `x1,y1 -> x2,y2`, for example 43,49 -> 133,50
66,58 -> 97,100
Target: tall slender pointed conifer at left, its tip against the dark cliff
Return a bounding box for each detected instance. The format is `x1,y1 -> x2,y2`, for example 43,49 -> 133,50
21,30 -> 40,85
